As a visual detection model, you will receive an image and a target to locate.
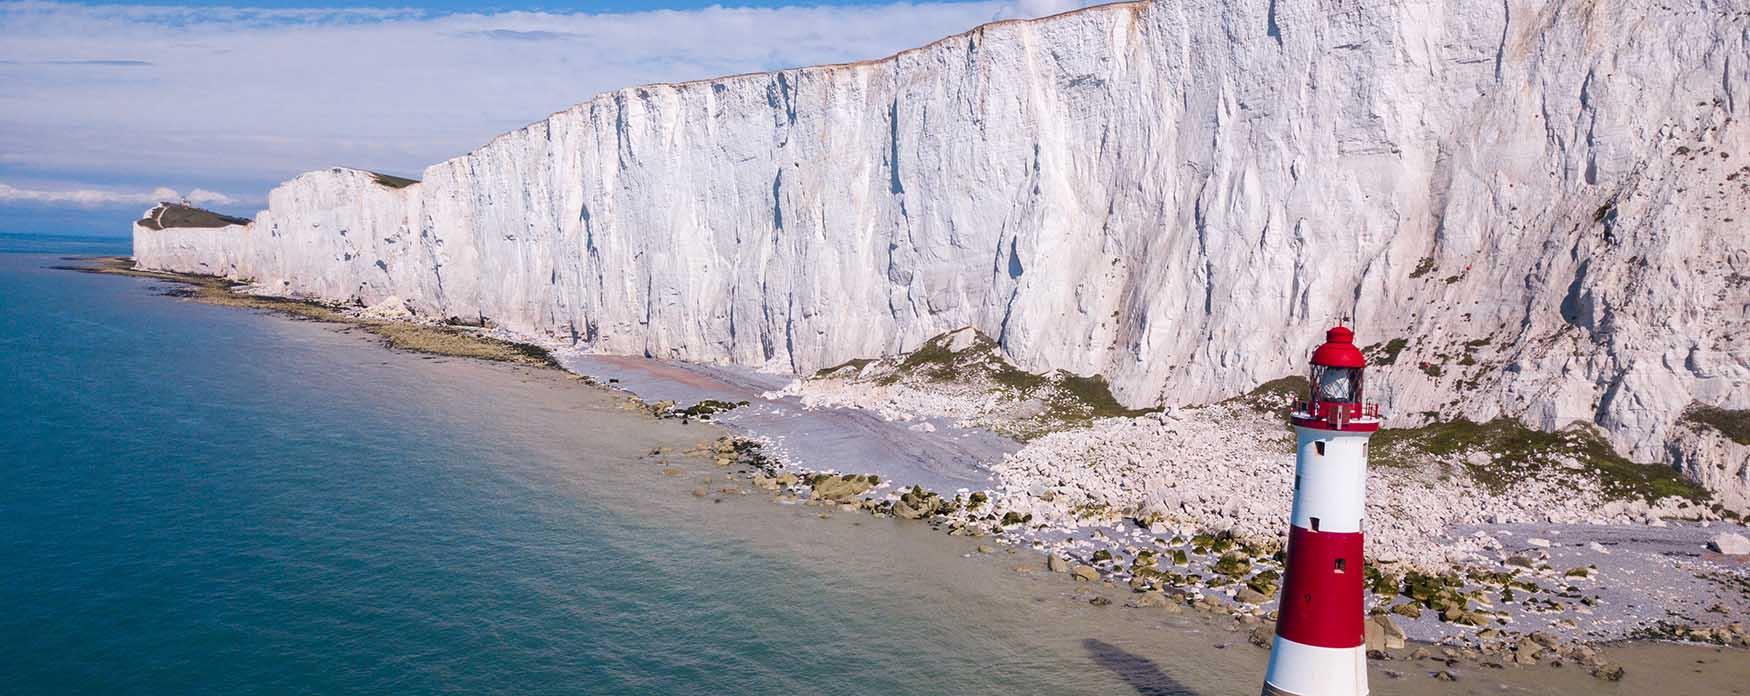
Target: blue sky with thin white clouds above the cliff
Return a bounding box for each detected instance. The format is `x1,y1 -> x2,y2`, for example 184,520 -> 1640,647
0,0 -> 1087,236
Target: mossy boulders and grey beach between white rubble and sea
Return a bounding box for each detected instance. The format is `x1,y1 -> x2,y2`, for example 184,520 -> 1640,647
651,412 -> 1750,657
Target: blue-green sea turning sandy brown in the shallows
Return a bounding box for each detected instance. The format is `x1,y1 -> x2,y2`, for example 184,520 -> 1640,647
0,241 -> 1750,694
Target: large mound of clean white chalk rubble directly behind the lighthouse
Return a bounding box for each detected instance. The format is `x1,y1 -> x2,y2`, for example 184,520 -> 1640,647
992,406 -> 1717,570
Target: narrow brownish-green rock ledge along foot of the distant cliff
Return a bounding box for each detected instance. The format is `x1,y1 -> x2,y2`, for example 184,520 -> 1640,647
63,257 -> 558,367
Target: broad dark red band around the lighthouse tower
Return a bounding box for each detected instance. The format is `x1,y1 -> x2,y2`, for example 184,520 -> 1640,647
1276,526 -> 1367,647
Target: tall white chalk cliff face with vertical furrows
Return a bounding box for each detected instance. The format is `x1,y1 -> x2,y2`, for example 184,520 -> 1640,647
135,0 -> 1750,507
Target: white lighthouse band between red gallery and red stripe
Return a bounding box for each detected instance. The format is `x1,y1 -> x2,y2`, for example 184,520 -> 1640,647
1290,427 -> 1372,533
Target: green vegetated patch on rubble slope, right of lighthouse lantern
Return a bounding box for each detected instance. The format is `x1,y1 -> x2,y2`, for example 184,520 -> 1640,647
1370,418 -> 1708,502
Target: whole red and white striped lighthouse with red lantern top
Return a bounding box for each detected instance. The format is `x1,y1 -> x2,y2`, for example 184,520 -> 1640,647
1264,325 -> 1379,696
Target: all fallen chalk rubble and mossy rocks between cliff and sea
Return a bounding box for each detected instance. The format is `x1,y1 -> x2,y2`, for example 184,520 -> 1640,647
768,332 -> 1750,659
